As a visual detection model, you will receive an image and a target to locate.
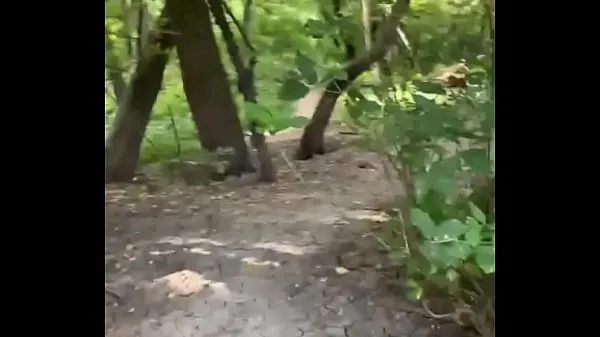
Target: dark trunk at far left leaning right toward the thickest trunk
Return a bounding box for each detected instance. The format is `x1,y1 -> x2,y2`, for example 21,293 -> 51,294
105,11 -> 173,182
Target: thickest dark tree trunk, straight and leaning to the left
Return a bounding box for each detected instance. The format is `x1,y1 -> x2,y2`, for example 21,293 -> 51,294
166,0 -> 254,175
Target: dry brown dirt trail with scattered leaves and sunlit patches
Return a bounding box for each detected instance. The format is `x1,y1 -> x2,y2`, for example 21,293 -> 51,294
105,91 -> 460,337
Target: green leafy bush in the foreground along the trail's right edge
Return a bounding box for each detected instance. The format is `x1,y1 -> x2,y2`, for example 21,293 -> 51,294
346,61 -> 495,336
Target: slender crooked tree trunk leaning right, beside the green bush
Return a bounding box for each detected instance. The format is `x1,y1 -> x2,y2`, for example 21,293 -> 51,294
296,0 -> 410,160
